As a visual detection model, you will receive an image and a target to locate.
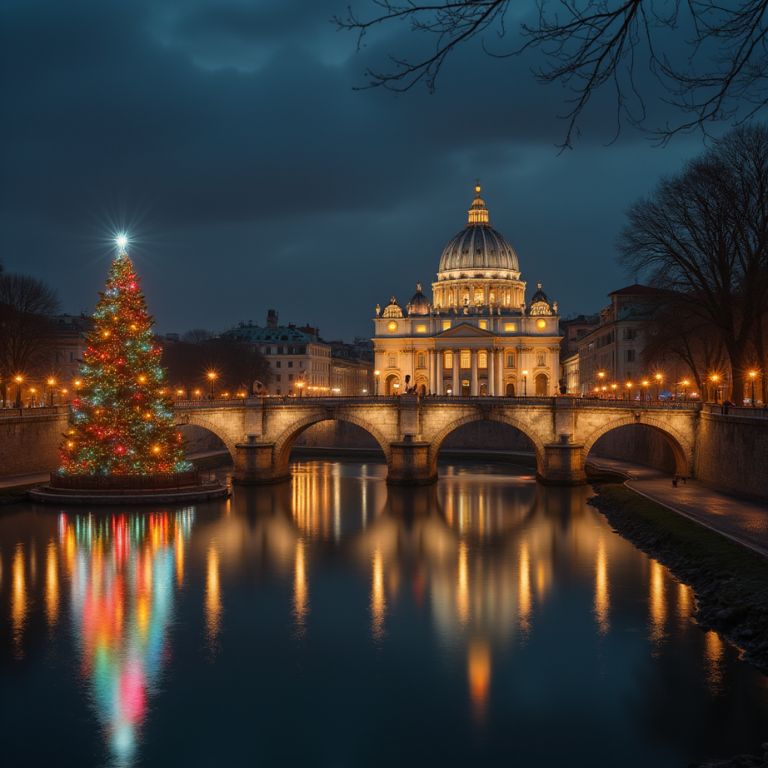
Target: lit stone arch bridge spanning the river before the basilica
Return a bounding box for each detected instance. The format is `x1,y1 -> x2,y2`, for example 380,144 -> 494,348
175,395 -> 700,485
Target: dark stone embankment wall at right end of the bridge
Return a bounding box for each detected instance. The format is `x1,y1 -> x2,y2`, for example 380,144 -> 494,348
695,409 -> 768,500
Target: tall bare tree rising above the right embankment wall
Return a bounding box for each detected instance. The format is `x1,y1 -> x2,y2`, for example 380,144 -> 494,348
619,125 -> 768,403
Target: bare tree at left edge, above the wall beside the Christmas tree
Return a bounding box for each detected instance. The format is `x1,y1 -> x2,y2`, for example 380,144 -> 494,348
0,272 -> 59,402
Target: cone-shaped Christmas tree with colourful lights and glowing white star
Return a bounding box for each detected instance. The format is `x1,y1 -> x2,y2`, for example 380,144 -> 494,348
59,236 -> 192,475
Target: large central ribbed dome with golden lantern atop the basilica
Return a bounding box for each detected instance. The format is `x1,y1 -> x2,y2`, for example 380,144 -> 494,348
438,184 -> 520,280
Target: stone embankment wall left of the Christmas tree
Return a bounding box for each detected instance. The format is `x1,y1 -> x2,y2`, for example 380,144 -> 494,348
0,408 -> 67,476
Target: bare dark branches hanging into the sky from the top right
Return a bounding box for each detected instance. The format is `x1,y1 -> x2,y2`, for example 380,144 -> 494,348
335,0 -> 768,147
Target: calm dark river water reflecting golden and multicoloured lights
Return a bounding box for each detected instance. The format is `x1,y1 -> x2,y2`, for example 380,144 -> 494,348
0,461 -> 768,768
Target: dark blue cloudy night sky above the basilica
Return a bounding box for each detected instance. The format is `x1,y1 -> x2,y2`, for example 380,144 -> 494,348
0,0 -> 702,340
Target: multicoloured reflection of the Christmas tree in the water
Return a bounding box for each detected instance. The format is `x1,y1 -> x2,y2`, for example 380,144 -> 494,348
63,510 -> 193,766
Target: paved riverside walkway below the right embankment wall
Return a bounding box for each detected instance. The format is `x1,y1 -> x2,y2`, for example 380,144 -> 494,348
587,457 -> 768,557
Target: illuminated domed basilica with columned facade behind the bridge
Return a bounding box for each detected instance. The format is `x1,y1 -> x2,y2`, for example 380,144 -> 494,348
373,185 -> 561,397
